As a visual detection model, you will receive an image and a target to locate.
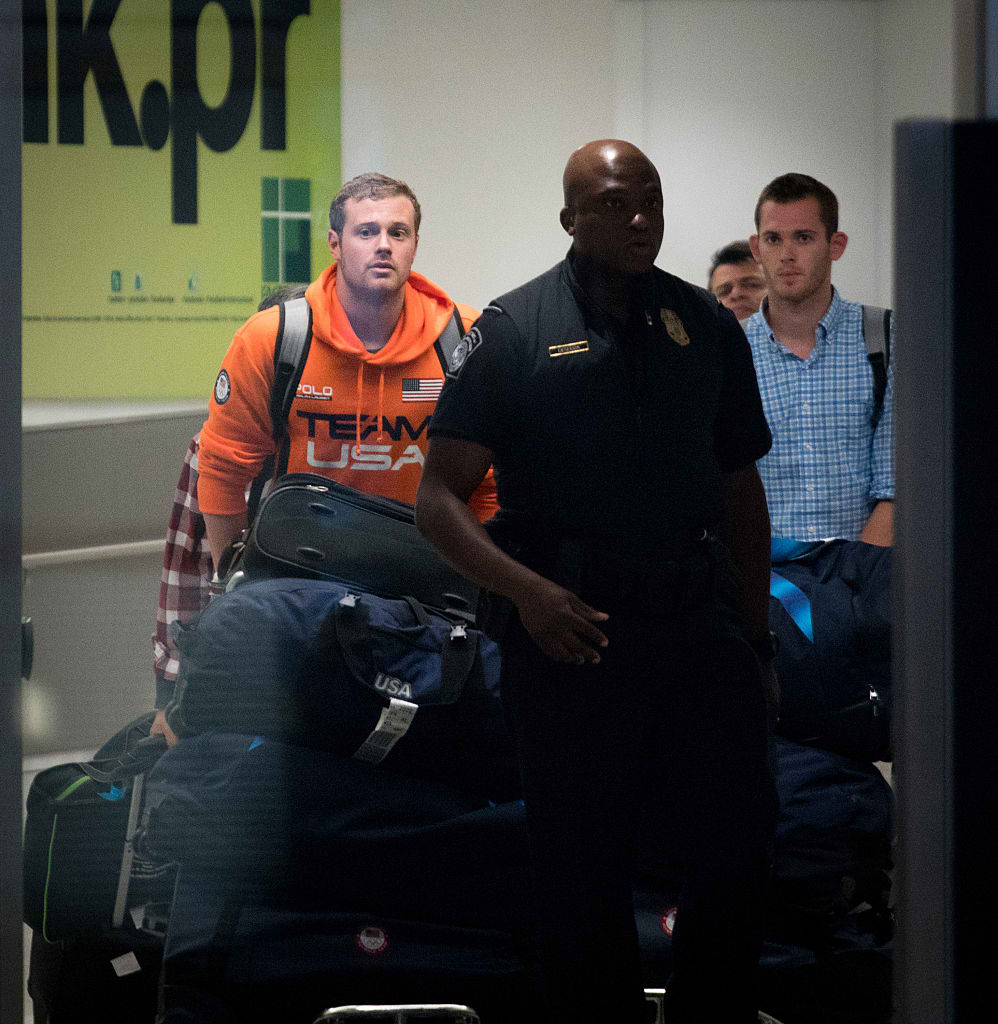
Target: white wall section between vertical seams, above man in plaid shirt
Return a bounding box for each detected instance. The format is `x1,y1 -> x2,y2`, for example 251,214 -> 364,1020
644,0 -> 881,301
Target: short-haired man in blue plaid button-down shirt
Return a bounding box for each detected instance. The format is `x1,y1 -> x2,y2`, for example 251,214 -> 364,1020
743,174 -> 894,545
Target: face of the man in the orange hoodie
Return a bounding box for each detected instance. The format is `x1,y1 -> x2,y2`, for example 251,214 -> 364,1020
330,196 -> 419,298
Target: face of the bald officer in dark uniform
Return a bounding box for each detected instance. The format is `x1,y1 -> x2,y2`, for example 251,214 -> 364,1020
562,147 -> 665,276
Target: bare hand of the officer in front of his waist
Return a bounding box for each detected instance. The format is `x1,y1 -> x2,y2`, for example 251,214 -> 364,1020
516,579 -> 610,665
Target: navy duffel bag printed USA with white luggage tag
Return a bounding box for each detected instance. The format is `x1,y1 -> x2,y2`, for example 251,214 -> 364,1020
167,579 -> 518,800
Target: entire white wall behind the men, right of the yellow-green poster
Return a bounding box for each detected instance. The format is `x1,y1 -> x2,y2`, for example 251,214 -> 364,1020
342,0 -> 958,305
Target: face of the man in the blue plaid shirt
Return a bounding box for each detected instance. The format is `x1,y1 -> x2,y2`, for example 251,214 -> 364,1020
748,196 -> 847,304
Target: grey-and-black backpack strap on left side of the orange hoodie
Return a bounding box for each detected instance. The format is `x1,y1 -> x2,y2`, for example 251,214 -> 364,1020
247,296 -> 312,523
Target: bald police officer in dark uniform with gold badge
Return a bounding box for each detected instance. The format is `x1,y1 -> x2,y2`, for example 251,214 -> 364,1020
417,139 -> 775,1024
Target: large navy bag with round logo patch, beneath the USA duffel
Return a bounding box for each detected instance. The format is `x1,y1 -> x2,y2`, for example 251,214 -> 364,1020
140,733 -> 532,1021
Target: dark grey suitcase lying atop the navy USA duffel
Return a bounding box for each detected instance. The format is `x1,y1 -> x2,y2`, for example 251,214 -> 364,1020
219,473 -> 479,621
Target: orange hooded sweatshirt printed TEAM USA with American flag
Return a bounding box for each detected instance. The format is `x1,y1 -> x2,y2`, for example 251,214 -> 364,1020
198,265 -> 497,520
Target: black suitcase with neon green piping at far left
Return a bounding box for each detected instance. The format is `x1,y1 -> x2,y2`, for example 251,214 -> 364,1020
24,712 -> 176,1024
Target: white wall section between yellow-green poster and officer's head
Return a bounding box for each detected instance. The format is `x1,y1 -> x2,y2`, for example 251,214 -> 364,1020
341,0 -> 614,306
